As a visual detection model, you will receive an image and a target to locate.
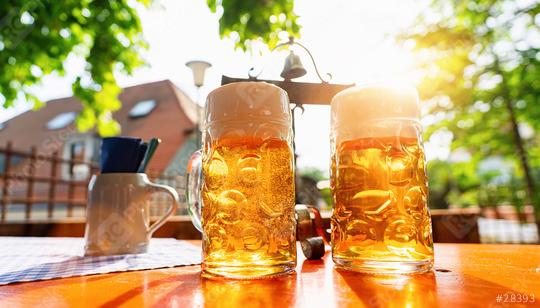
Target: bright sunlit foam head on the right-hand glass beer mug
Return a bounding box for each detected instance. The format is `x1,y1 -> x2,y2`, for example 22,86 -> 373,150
331,85 -> 420,140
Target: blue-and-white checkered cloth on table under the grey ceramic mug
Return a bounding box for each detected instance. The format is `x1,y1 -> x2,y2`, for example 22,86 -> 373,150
0,237 -> 201,285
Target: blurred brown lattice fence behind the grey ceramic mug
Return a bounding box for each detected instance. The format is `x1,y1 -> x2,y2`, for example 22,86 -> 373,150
0,142 -> 187,223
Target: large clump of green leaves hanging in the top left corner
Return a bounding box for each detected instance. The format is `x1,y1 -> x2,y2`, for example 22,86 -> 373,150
0,0 -> 146,135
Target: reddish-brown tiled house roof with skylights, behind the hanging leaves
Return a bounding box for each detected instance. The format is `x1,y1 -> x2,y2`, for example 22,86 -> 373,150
0,80 -> 198,172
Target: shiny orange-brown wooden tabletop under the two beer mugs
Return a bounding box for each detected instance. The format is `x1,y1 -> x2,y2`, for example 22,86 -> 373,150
0,241 -> 540,308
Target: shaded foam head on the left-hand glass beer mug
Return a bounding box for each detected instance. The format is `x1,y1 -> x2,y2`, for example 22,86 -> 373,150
205,82 -> 291,125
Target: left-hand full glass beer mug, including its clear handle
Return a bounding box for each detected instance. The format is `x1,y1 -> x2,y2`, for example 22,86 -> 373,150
186,82 -> 296,278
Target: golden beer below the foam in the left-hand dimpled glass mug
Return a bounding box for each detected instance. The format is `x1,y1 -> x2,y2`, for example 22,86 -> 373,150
202,137 -> 296,276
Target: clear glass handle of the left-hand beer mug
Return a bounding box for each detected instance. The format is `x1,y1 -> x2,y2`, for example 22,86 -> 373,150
186,150 -> 202,232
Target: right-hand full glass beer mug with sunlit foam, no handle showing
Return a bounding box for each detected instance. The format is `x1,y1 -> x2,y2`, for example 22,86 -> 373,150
330,85 -> 433,274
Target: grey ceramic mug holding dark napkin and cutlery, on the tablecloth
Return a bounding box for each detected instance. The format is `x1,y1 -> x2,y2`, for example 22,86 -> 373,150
84,173 -> 178,256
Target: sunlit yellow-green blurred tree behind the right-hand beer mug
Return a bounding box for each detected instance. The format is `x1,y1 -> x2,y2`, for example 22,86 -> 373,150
401,0 -> 540,219
